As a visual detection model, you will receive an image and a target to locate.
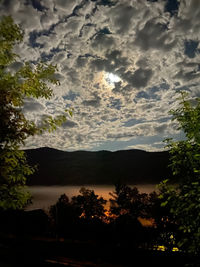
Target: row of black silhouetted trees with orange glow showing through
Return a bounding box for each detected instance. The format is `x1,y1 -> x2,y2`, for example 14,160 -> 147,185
0,184 -> 178,251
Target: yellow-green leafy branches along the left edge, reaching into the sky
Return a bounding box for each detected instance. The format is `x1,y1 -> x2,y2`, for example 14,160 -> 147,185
0,17 -> 68,209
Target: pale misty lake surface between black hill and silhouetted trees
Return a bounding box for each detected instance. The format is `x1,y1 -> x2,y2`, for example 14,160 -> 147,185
27,184 -> 156,211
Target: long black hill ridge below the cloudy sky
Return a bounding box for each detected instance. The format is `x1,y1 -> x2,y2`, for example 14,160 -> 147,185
25,147 -> 170,185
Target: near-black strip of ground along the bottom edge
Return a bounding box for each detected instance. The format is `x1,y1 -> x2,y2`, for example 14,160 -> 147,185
0,235 -> 200,267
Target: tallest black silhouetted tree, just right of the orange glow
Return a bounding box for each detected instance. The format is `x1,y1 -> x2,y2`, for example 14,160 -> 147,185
110,184 -> 146,246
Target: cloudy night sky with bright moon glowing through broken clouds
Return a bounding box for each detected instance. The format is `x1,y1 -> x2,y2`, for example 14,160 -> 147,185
0,0 -> 200,151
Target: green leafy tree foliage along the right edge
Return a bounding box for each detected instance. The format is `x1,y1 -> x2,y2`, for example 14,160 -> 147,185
160,92 -> 200,253
